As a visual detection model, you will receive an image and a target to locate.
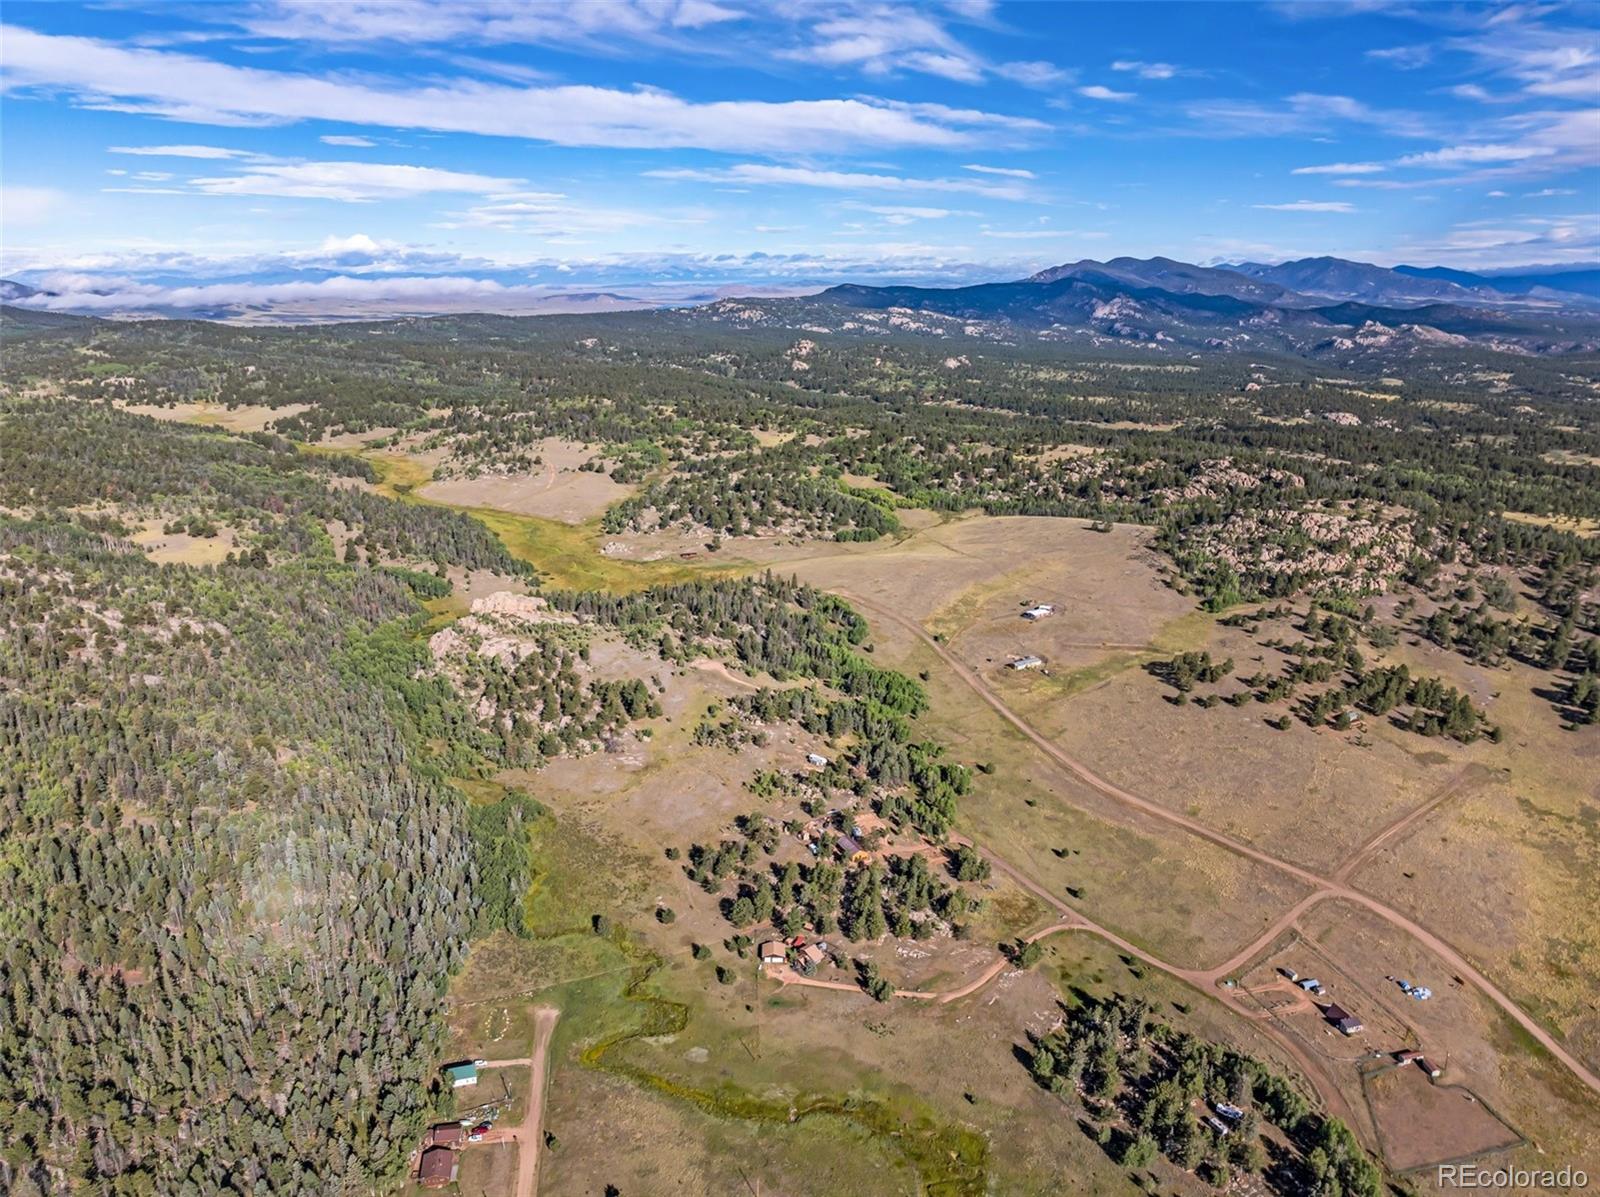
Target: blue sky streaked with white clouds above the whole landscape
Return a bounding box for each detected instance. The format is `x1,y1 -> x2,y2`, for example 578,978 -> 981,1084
0,0 -> 1600,308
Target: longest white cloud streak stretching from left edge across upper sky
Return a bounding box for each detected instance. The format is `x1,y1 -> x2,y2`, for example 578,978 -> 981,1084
3,26 -> 1040,154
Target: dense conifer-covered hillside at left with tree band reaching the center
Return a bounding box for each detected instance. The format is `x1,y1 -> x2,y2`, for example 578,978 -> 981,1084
0,371 -> 985,1194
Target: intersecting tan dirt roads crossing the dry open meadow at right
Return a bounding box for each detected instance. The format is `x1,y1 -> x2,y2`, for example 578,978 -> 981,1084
848,594 -> 1600,1104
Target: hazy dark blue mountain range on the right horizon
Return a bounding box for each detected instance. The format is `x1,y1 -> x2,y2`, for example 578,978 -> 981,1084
691,258 -> 1600,363
